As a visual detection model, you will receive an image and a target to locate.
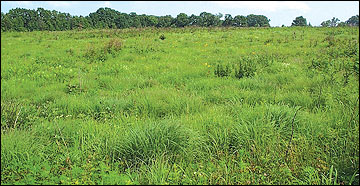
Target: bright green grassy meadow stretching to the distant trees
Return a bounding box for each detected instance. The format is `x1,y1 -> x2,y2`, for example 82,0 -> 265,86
1,27 -> 359,184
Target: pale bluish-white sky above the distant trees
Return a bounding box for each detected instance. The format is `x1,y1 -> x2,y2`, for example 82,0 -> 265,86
1,1 -> 359,26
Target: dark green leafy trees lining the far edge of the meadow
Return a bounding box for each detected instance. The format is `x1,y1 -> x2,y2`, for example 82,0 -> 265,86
1,8 -> 359,31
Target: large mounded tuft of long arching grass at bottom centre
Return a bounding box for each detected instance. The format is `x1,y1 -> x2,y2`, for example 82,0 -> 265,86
114,122 -> 193,166
